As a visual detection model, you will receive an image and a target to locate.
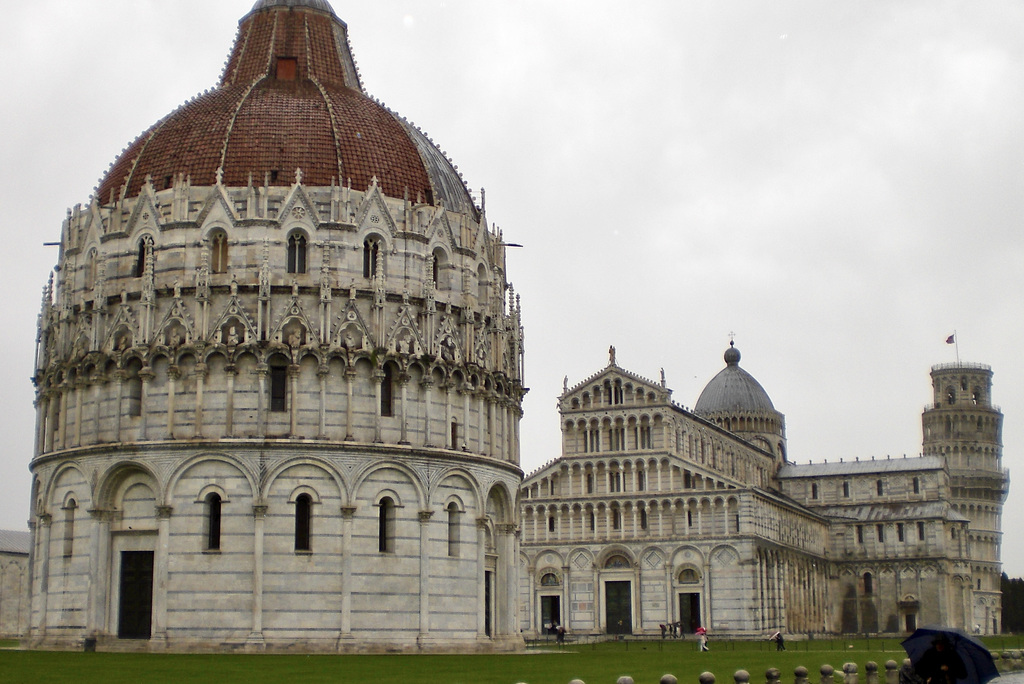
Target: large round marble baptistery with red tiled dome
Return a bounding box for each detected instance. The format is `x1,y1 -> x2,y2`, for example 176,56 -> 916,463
26,0 -> 526,651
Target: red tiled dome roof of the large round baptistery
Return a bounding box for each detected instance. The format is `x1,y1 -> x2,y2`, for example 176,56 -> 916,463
98,0 -> 475,212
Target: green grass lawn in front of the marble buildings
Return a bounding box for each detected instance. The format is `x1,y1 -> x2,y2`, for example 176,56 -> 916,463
0,637 -> 1021,684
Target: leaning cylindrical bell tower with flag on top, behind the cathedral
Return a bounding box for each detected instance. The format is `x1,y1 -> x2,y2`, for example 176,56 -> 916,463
922,364 -> 1010,634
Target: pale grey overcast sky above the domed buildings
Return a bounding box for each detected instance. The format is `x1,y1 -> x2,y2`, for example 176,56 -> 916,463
0,0 -> 1024,576
